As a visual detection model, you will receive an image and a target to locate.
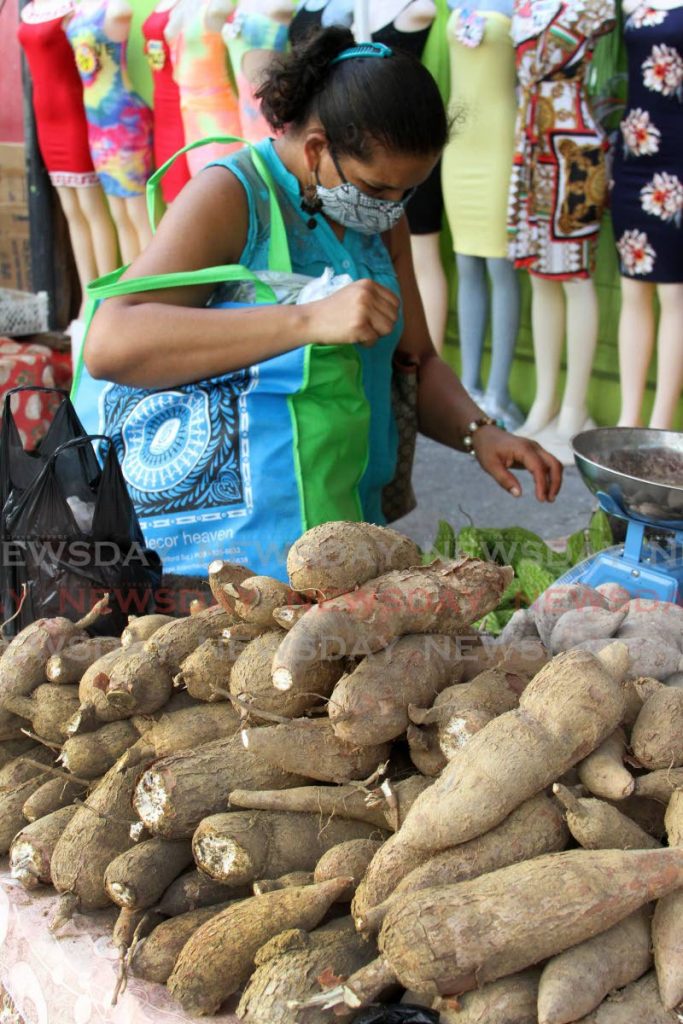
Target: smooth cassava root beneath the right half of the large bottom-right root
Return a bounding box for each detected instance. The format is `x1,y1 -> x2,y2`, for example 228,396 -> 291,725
539,909 -> 655,1024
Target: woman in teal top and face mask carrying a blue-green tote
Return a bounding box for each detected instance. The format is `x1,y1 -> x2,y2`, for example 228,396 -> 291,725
85,28 -> 561,575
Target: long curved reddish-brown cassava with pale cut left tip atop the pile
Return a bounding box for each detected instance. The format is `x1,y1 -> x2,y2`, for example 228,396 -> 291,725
272,558 -> 513,690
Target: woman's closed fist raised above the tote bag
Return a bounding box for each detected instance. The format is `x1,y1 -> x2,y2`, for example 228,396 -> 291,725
299,280 -> 400,346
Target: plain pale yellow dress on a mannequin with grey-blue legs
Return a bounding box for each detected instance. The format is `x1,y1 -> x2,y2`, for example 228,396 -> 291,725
442,8 -> 517,259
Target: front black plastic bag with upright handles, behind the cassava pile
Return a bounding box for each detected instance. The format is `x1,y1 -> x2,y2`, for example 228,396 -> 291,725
0,434 -> 161,636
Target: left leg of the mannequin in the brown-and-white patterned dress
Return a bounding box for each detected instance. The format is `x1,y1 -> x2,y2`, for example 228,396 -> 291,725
519,274 -> 564,436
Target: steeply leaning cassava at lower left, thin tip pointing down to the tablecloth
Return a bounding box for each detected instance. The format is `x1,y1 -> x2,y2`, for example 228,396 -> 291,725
51,768 -> 139,916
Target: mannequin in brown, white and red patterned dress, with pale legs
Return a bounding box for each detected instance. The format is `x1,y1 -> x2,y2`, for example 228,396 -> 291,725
508,0 -> 614,463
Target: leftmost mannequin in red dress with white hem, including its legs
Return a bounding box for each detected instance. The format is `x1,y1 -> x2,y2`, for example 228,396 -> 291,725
18,0 -> 117,312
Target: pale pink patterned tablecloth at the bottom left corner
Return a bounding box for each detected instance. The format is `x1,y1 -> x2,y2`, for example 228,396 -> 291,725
0,858 -> 238,1024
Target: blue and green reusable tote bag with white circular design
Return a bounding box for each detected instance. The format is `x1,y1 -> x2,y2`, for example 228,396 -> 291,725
73,138 -> 369,579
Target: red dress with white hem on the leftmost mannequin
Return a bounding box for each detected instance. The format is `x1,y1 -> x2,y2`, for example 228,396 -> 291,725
17,3 -> 99,187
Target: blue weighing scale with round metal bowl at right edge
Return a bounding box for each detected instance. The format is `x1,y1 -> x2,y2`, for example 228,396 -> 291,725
560,427 -> 683,604
